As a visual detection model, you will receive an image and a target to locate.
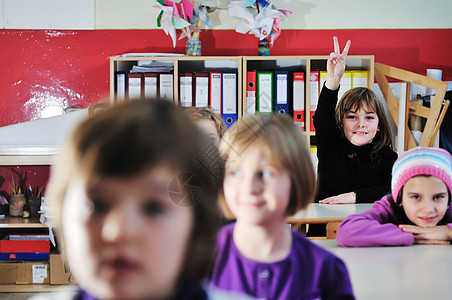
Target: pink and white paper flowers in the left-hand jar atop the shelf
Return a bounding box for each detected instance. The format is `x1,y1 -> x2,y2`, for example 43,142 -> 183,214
154,0 -> 220,47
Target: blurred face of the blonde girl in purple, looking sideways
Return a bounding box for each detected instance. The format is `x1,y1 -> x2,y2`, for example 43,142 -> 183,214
223,145 -> 291,225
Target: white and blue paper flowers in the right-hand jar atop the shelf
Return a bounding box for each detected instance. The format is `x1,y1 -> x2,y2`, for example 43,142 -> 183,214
228,0 -> 292,45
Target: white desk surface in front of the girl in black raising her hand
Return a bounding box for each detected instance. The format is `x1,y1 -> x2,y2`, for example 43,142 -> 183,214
288,203 -> 373,224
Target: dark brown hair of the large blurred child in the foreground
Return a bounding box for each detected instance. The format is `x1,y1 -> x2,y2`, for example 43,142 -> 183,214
46,100 -> 223,282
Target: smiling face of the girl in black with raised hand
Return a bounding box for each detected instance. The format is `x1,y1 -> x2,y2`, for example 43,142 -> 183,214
342,104 -> 378,146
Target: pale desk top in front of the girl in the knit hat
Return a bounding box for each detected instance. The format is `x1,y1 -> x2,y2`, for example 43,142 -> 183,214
313,240 -> 452,300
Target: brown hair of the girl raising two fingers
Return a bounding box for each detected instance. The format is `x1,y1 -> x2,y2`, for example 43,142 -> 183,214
336,87 -> 392,163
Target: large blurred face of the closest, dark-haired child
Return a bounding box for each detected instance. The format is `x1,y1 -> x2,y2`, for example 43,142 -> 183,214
62,166 -> 193,299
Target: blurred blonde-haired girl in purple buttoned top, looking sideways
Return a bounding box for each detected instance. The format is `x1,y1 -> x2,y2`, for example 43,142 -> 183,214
209,115 -> 354,300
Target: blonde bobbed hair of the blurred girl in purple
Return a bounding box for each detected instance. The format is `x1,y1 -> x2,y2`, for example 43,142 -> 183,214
219,114 -> 315,218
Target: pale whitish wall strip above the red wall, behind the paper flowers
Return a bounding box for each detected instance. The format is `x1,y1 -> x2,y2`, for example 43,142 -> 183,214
0,0 -> 452,29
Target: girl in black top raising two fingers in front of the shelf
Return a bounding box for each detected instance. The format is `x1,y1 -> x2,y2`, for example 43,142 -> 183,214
314,37 -> 397,204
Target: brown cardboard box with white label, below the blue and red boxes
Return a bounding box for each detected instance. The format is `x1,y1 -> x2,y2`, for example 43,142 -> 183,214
0,261 -> 49,284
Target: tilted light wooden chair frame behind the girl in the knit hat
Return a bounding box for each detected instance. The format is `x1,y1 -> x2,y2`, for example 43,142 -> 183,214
375,63 -> 449,150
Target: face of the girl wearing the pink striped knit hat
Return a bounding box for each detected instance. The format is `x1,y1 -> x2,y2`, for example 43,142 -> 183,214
402,176 -> 449,227
